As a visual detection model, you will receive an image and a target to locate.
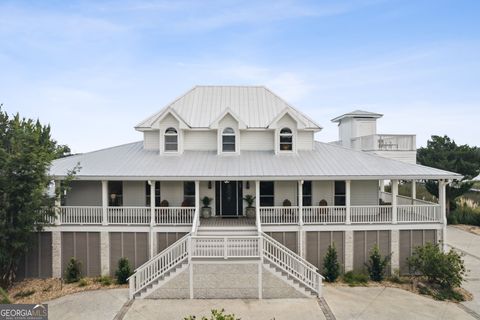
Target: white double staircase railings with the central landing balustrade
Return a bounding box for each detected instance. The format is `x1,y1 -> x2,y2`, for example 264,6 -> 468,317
129,213 -> 323,299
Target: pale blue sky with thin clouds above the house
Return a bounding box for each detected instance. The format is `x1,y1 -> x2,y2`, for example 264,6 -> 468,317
0,0 -> 480,152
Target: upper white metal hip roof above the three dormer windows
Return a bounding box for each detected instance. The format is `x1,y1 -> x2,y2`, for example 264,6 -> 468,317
135,86 -> 321,130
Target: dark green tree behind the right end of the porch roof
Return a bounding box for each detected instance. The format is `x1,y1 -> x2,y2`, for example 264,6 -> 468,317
417,136 -> 480,213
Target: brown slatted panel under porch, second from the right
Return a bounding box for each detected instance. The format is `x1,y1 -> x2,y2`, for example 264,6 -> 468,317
353,230 -> 391,273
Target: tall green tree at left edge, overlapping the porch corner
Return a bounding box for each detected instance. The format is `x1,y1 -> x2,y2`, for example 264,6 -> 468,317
0,105 -> 75,288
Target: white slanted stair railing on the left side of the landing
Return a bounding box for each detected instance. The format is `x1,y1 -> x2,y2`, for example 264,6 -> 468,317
127,233 -> 191,299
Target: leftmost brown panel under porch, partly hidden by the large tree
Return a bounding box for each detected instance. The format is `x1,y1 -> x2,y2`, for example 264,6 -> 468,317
17,232 -> 52,280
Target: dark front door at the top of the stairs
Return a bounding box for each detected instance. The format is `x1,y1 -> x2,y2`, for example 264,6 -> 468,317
215,181 -> 243,217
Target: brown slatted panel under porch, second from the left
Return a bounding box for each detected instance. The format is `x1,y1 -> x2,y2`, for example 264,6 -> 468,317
62,232 -> 100,277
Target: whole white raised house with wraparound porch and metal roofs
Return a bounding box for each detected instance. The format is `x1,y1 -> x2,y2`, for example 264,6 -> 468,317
20,86 -> 460,298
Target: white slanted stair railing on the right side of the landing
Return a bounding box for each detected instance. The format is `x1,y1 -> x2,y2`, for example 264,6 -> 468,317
262,233 -> 324,296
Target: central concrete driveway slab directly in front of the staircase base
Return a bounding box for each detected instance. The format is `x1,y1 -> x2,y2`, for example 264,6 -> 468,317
123,299 -> 325,320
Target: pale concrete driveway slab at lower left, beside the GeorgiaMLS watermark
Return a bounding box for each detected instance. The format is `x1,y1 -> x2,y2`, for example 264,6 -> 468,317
45,289 -> 128,320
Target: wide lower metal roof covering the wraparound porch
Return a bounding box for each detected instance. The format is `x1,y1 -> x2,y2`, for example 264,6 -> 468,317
50,141 -> 461,180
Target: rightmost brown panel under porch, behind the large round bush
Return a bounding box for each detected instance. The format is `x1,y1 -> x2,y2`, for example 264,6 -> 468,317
400,230 -> 437,274
